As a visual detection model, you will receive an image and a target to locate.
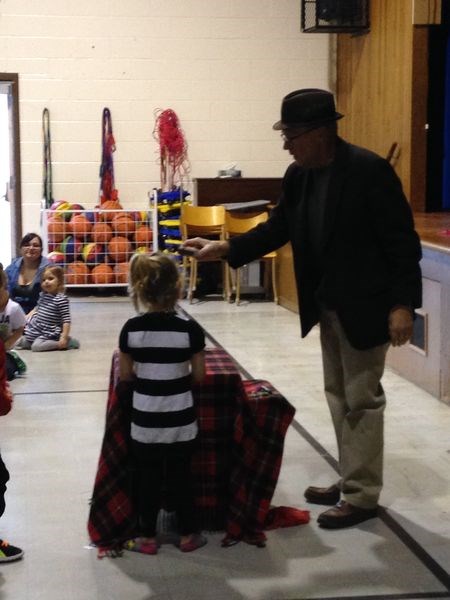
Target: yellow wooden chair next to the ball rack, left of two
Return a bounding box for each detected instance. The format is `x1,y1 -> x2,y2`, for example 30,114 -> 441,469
180,204 -> 229,303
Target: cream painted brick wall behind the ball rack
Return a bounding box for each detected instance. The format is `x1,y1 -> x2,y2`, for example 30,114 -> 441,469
0,0 -> 332,231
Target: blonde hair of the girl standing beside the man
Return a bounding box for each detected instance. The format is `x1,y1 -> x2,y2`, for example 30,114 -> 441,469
129,252 -> 180,311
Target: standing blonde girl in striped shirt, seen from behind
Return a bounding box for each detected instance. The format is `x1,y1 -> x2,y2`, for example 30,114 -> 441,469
119,253 -> 206,554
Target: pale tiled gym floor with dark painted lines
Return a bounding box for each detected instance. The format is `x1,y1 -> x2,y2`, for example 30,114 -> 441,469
0,295 -> 450,600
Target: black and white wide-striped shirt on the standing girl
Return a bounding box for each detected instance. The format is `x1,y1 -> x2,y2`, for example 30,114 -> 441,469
119,312 -> 205,444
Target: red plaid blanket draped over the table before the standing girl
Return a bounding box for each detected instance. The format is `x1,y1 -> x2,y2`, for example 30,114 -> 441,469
88,348 -> 294,546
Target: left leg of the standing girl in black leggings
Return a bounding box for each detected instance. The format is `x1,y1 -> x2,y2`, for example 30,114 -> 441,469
133,442 -> 164,537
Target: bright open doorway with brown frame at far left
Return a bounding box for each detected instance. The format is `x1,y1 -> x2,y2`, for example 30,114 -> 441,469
0,73 -> 22,266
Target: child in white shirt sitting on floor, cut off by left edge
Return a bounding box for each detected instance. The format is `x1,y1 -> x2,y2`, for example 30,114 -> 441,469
0,263 -> 27,381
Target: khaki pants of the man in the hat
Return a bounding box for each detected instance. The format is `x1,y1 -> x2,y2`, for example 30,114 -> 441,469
320,310 -> 389,508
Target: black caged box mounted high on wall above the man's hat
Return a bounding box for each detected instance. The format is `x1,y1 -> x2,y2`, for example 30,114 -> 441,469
302,0 -> 370,33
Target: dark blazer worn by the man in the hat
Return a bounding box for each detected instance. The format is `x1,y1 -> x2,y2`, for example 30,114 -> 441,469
228,138 -> 422,350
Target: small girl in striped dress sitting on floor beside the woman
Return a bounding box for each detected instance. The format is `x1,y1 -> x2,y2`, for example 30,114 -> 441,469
17,265 -> 80,352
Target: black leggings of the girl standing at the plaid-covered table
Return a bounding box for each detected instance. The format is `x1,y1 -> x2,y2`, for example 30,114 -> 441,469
132,441 -> 198,537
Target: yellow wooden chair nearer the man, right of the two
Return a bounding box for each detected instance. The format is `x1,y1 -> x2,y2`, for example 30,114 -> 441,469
225,212 -> 278,304
